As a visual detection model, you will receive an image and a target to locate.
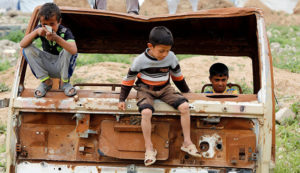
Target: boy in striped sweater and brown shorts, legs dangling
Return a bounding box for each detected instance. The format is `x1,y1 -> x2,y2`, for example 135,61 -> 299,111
118,26 -> 201,166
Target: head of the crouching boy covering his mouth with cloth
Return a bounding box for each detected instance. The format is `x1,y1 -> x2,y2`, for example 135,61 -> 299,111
38,3 -> 61,32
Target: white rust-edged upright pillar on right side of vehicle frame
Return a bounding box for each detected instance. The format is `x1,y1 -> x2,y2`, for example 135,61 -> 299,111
257,17 -> 275,172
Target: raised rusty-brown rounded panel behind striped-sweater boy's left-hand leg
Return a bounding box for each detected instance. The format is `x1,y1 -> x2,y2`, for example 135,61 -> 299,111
99,120 -> 170,160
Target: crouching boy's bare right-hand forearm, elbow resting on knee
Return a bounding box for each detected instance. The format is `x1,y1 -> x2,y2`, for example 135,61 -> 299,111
46,32 -> 77,55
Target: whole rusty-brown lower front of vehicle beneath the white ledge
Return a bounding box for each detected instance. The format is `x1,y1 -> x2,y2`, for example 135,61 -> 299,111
18,113 -> 256,169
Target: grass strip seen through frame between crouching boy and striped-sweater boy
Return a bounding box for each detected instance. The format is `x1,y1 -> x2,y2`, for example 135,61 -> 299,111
76,54 -> 136,66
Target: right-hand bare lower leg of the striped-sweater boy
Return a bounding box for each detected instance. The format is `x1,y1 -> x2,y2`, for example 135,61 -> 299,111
178,102 -> 193,146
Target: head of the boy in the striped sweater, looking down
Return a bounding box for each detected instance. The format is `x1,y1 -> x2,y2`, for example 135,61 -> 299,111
147,26 -> 174,60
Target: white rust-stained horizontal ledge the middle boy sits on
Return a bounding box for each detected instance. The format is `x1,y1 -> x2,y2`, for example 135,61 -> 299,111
14,91 -> 264,117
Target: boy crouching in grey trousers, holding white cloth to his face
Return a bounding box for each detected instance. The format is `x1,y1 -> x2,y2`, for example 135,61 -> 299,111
20,3 -> 77,98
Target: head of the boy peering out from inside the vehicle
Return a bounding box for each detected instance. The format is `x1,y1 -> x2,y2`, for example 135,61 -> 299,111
209,63 -> 229,93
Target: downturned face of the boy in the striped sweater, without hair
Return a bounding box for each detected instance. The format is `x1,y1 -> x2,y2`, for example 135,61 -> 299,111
147,43 -> 172,61
